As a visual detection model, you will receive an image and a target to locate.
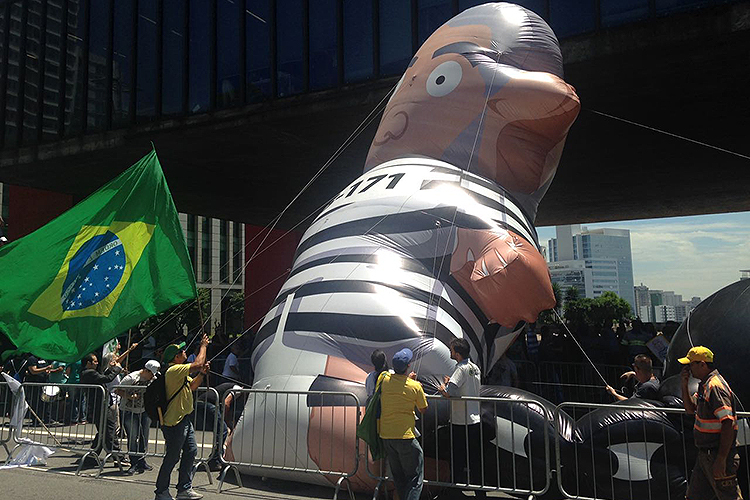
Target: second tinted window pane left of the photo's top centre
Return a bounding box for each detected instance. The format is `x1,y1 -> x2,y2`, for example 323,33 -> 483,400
310,0 -> 338,89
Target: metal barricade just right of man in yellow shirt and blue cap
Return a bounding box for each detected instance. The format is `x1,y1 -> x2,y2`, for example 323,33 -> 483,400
366,396 -> 555,499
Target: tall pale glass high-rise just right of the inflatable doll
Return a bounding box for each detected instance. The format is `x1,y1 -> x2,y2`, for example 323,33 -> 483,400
547,225 -> 636,311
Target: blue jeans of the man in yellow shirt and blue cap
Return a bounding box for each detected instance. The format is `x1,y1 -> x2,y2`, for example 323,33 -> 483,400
383,439 -> 424,500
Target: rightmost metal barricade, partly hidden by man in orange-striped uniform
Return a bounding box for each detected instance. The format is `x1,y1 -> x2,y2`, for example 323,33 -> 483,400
555,400 -> 750,500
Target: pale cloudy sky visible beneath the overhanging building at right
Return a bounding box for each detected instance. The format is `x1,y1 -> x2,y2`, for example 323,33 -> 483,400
537,212 -> 750,300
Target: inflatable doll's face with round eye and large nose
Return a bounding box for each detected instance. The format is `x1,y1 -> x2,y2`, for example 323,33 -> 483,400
366,24 -> 580,194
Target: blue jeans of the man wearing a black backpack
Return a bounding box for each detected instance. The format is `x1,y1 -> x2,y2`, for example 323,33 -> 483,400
155,415 -> 198,495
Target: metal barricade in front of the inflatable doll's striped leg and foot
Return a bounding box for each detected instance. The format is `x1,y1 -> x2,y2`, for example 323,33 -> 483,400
218,389 -> 361,499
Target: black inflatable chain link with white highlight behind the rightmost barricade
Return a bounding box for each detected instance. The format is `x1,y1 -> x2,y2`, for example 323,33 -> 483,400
563,398 -> 694,500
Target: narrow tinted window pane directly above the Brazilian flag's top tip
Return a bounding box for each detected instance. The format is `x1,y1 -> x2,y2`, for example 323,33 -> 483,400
136,1 -> 156,120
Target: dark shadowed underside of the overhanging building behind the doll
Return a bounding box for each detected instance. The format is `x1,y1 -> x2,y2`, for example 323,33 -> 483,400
0,2 -> 750,227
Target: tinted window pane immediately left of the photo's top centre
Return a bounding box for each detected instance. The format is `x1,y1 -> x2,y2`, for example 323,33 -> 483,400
344,0 -> 373,83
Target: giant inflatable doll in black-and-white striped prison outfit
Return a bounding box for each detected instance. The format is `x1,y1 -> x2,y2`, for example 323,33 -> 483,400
232,3 -> 580,488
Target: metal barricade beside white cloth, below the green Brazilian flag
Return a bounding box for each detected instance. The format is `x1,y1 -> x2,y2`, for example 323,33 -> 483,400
8,382 -> 109,472
